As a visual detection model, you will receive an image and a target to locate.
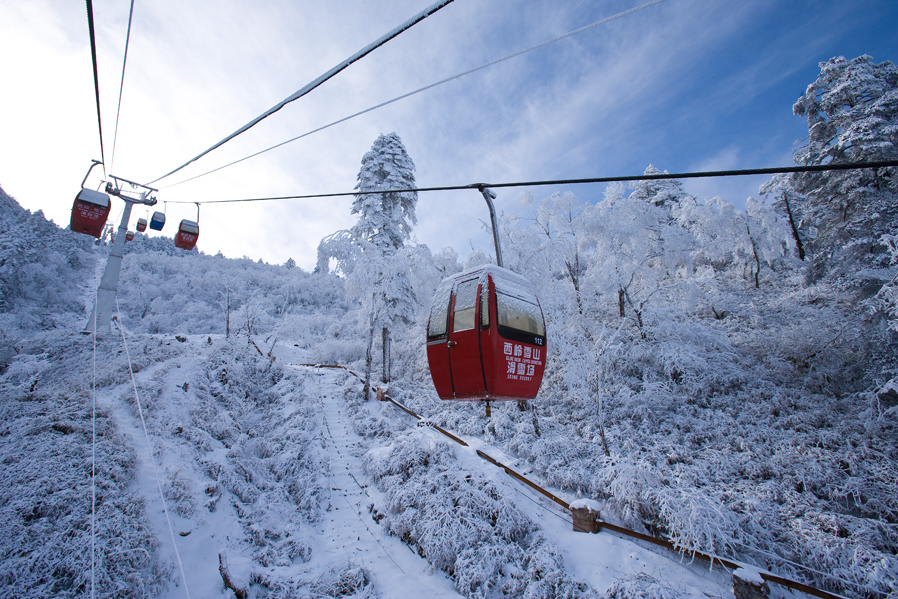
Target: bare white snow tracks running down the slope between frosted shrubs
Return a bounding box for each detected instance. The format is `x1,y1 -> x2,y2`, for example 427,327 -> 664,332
80,335 -> 731,598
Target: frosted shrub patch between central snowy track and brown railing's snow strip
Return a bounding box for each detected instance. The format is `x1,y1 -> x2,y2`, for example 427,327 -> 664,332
365,428 -> 590,598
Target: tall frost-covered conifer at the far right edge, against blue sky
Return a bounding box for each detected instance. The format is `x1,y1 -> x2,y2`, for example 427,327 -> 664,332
784,55 -> 898,280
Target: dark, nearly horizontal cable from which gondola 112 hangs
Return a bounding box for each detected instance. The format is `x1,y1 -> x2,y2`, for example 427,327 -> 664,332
167,160 -> 898,204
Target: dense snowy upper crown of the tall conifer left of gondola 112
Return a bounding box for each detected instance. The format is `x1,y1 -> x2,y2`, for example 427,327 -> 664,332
352,133 -> 418,253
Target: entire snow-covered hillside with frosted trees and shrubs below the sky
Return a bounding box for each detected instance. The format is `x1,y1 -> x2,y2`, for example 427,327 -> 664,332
0,57 -> 898,598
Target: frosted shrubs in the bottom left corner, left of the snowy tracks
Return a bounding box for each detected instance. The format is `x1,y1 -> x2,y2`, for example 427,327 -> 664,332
0,335 -> 169,599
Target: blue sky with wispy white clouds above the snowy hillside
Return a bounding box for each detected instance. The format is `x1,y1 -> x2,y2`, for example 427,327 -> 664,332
0,0 -> 898,268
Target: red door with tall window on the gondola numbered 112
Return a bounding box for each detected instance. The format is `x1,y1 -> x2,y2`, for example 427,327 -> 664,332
447,273 -> 486,399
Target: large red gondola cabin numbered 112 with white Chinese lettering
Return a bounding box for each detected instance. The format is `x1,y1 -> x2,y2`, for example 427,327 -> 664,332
427,265 -> 546,401
